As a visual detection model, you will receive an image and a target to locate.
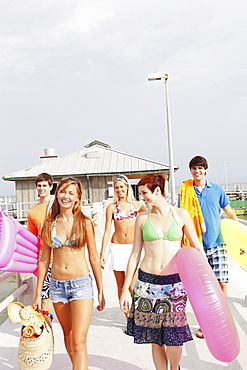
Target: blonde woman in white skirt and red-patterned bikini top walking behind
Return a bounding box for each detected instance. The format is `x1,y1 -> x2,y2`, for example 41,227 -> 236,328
100,175 -> 146,316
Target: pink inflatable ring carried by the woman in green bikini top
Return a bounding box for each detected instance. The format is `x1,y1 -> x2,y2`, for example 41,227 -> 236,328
177,247 -> 240,362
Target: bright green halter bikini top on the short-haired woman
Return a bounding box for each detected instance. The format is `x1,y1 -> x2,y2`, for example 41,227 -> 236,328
142,208 -> 183,242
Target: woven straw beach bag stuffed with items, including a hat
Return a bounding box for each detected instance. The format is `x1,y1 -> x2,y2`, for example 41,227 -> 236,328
8,302 -> 54,370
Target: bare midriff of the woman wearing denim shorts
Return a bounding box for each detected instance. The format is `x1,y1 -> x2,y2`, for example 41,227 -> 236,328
51,246 -> 89,280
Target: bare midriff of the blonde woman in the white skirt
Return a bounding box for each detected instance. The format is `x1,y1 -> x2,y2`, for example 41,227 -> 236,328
111,219 -> 135,244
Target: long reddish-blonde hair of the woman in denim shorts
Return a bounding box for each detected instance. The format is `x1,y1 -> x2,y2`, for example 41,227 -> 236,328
41,177 -> 94,247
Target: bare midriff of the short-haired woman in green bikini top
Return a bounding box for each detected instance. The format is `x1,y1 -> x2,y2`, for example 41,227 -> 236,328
140,239 -> 181,275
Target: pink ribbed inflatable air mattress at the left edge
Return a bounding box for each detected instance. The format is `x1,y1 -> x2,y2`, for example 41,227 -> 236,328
0,210 -> 38,272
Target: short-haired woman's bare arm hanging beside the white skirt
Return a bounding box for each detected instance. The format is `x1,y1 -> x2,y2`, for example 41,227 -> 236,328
119,216 -> 143,312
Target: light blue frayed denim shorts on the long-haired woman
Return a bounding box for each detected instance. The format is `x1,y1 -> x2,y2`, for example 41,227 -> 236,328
50,273 -> 94,303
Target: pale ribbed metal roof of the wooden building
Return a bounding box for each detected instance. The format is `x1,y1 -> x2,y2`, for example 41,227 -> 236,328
3,140 -> 179,181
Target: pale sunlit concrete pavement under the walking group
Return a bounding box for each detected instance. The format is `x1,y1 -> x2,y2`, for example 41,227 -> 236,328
0,254 -> 247,370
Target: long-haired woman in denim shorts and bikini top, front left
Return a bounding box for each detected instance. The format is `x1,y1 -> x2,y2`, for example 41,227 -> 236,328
33,177 -> 105,369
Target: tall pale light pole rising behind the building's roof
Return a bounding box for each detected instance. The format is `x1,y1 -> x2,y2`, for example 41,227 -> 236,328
148,73 -> 176,205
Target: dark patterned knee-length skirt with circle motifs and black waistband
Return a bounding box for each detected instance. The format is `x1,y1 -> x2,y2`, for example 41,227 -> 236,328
127,269 -> 193,346
